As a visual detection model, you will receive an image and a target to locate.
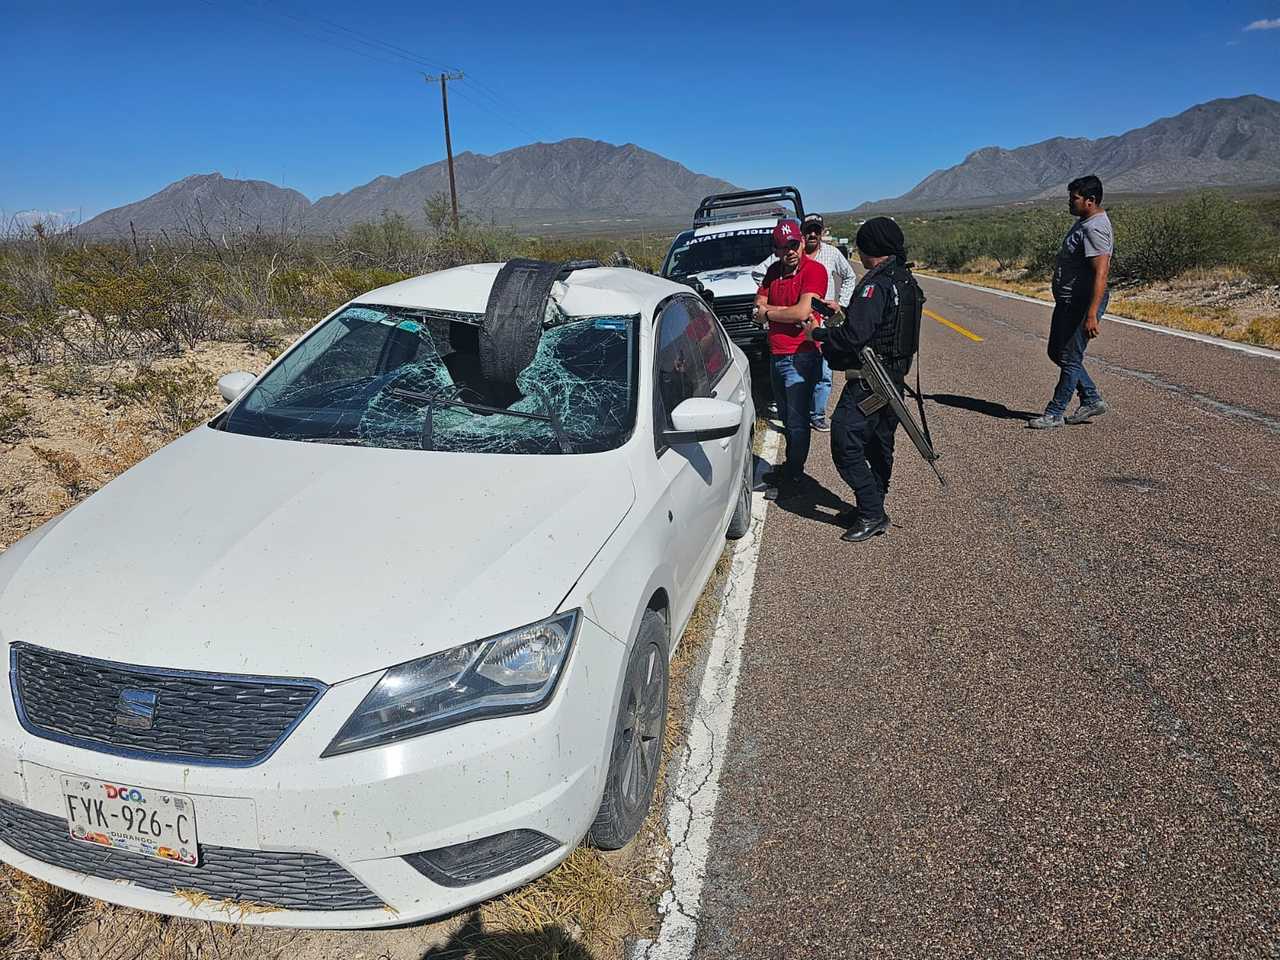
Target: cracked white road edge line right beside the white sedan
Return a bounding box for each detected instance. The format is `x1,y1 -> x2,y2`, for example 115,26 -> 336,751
630,431 -> 778,960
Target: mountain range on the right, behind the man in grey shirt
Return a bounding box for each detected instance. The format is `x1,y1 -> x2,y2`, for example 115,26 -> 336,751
855,96 -> 1280,214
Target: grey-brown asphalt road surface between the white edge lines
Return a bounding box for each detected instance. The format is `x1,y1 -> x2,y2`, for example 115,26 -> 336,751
695,280 -> 1280,960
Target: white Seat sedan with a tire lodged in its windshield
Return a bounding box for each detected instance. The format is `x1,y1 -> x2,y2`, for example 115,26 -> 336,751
0,261 -> 755,927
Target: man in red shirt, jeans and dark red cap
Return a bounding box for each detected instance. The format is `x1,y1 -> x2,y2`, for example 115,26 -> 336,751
755,220 -> 827,497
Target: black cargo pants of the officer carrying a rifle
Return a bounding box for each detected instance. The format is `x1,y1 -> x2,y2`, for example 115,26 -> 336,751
831,380 -> 901,520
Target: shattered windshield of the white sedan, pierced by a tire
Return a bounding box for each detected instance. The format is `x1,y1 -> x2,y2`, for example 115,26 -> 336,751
220,305 -> 637,453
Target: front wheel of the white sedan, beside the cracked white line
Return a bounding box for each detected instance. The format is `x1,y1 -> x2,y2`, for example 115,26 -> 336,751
586,611 -> 668,850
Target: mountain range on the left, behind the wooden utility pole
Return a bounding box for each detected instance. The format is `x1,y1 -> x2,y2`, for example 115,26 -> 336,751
79,138 -> 737,237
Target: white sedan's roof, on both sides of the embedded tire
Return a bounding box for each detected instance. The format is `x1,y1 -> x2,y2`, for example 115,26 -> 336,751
353,264 -> 689,316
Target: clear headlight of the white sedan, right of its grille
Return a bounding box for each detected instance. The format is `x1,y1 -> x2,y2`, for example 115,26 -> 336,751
320,611 -> 580,756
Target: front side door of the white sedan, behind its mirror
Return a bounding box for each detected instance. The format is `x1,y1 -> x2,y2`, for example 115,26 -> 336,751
653,296 -> 741,623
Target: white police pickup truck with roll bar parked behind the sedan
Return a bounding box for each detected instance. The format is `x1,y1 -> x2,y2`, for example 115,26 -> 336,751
662,187 -> 804,358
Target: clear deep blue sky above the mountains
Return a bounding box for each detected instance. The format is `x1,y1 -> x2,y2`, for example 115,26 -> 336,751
0,0 -> 1280,218
